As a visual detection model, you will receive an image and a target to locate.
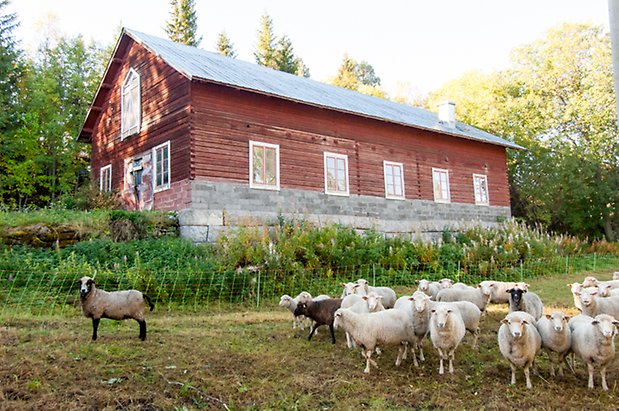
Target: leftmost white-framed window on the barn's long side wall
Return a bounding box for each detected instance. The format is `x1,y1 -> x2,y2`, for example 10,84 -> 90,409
249,141 -> 279,190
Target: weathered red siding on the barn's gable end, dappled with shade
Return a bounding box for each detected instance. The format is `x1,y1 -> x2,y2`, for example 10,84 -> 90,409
91,37 -> 191,193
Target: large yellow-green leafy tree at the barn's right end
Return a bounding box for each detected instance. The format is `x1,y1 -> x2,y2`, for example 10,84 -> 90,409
428,24 -> 619,240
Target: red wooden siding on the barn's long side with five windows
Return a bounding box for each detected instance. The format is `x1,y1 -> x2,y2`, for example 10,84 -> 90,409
191,82 -> 509,206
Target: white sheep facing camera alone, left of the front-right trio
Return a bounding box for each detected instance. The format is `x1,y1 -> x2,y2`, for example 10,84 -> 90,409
430,305 -> 466,374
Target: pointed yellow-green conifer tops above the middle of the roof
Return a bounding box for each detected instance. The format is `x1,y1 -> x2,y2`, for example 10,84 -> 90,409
254,13 -> 310,77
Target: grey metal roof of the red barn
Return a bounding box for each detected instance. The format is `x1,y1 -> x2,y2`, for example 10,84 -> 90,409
123,28 -> 523,149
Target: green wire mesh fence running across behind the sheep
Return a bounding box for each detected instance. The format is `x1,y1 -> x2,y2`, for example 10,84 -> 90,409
0,254 -> 619,318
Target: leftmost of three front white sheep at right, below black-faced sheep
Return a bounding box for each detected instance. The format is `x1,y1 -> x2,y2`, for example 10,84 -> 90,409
498,311 -> 542,388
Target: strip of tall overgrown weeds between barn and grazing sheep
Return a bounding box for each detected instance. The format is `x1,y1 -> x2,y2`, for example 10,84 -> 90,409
0,211 -> 619,313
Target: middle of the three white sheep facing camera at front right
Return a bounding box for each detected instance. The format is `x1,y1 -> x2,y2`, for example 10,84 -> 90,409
536,311 -> 572,377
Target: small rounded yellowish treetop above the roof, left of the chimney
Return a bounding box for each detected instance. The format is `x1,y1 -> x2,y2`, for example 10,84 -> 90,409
331,54 -> 386,98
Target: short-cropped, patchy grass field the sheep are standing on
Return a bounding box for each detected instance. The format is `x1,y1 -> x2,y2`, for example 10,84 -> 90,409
0,273 -> 619,410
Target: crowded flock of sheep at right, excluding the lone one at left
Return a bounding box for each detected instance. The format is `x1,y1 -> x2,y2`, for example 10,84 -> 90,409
279,272 -> 619,390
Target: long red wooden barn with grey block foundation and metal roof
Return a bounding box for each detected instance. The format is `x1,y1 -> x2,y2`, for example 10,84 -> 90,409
79,29 -> 521,241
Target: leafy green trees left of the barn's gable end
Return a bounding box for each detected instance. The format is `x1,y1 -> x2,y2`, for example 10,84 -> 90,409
0,13 -> 107,208
